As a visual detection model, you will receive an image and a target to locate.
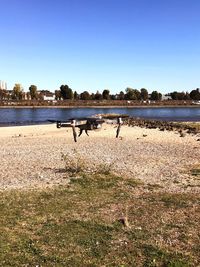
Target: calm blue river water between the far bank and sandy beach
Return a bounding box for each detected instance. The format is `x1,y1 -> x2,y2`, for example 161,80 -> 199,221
0,107 -> 200,126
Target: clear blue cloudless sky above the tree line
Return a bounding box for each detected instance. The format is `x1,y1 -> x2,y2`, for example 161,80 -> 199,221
0,0 -> 200,93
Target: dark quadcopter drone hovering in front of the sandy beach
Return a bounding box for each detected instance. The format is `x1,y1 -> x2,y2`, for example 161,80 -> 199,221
48,115 -> 129,142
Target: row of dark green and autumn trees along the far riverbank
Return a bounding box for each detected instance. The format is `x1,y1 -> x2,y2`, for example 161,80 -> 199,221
0,84 -> 200,101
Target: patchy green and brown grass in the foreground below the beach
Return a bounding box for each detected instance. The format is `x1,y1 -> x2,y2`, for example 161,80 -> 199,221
0,174 -> 200,267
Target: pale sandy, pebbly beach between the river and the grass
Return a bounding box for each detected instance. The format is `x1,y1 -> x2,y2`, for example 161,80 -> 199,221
0,124 -> 200,192
